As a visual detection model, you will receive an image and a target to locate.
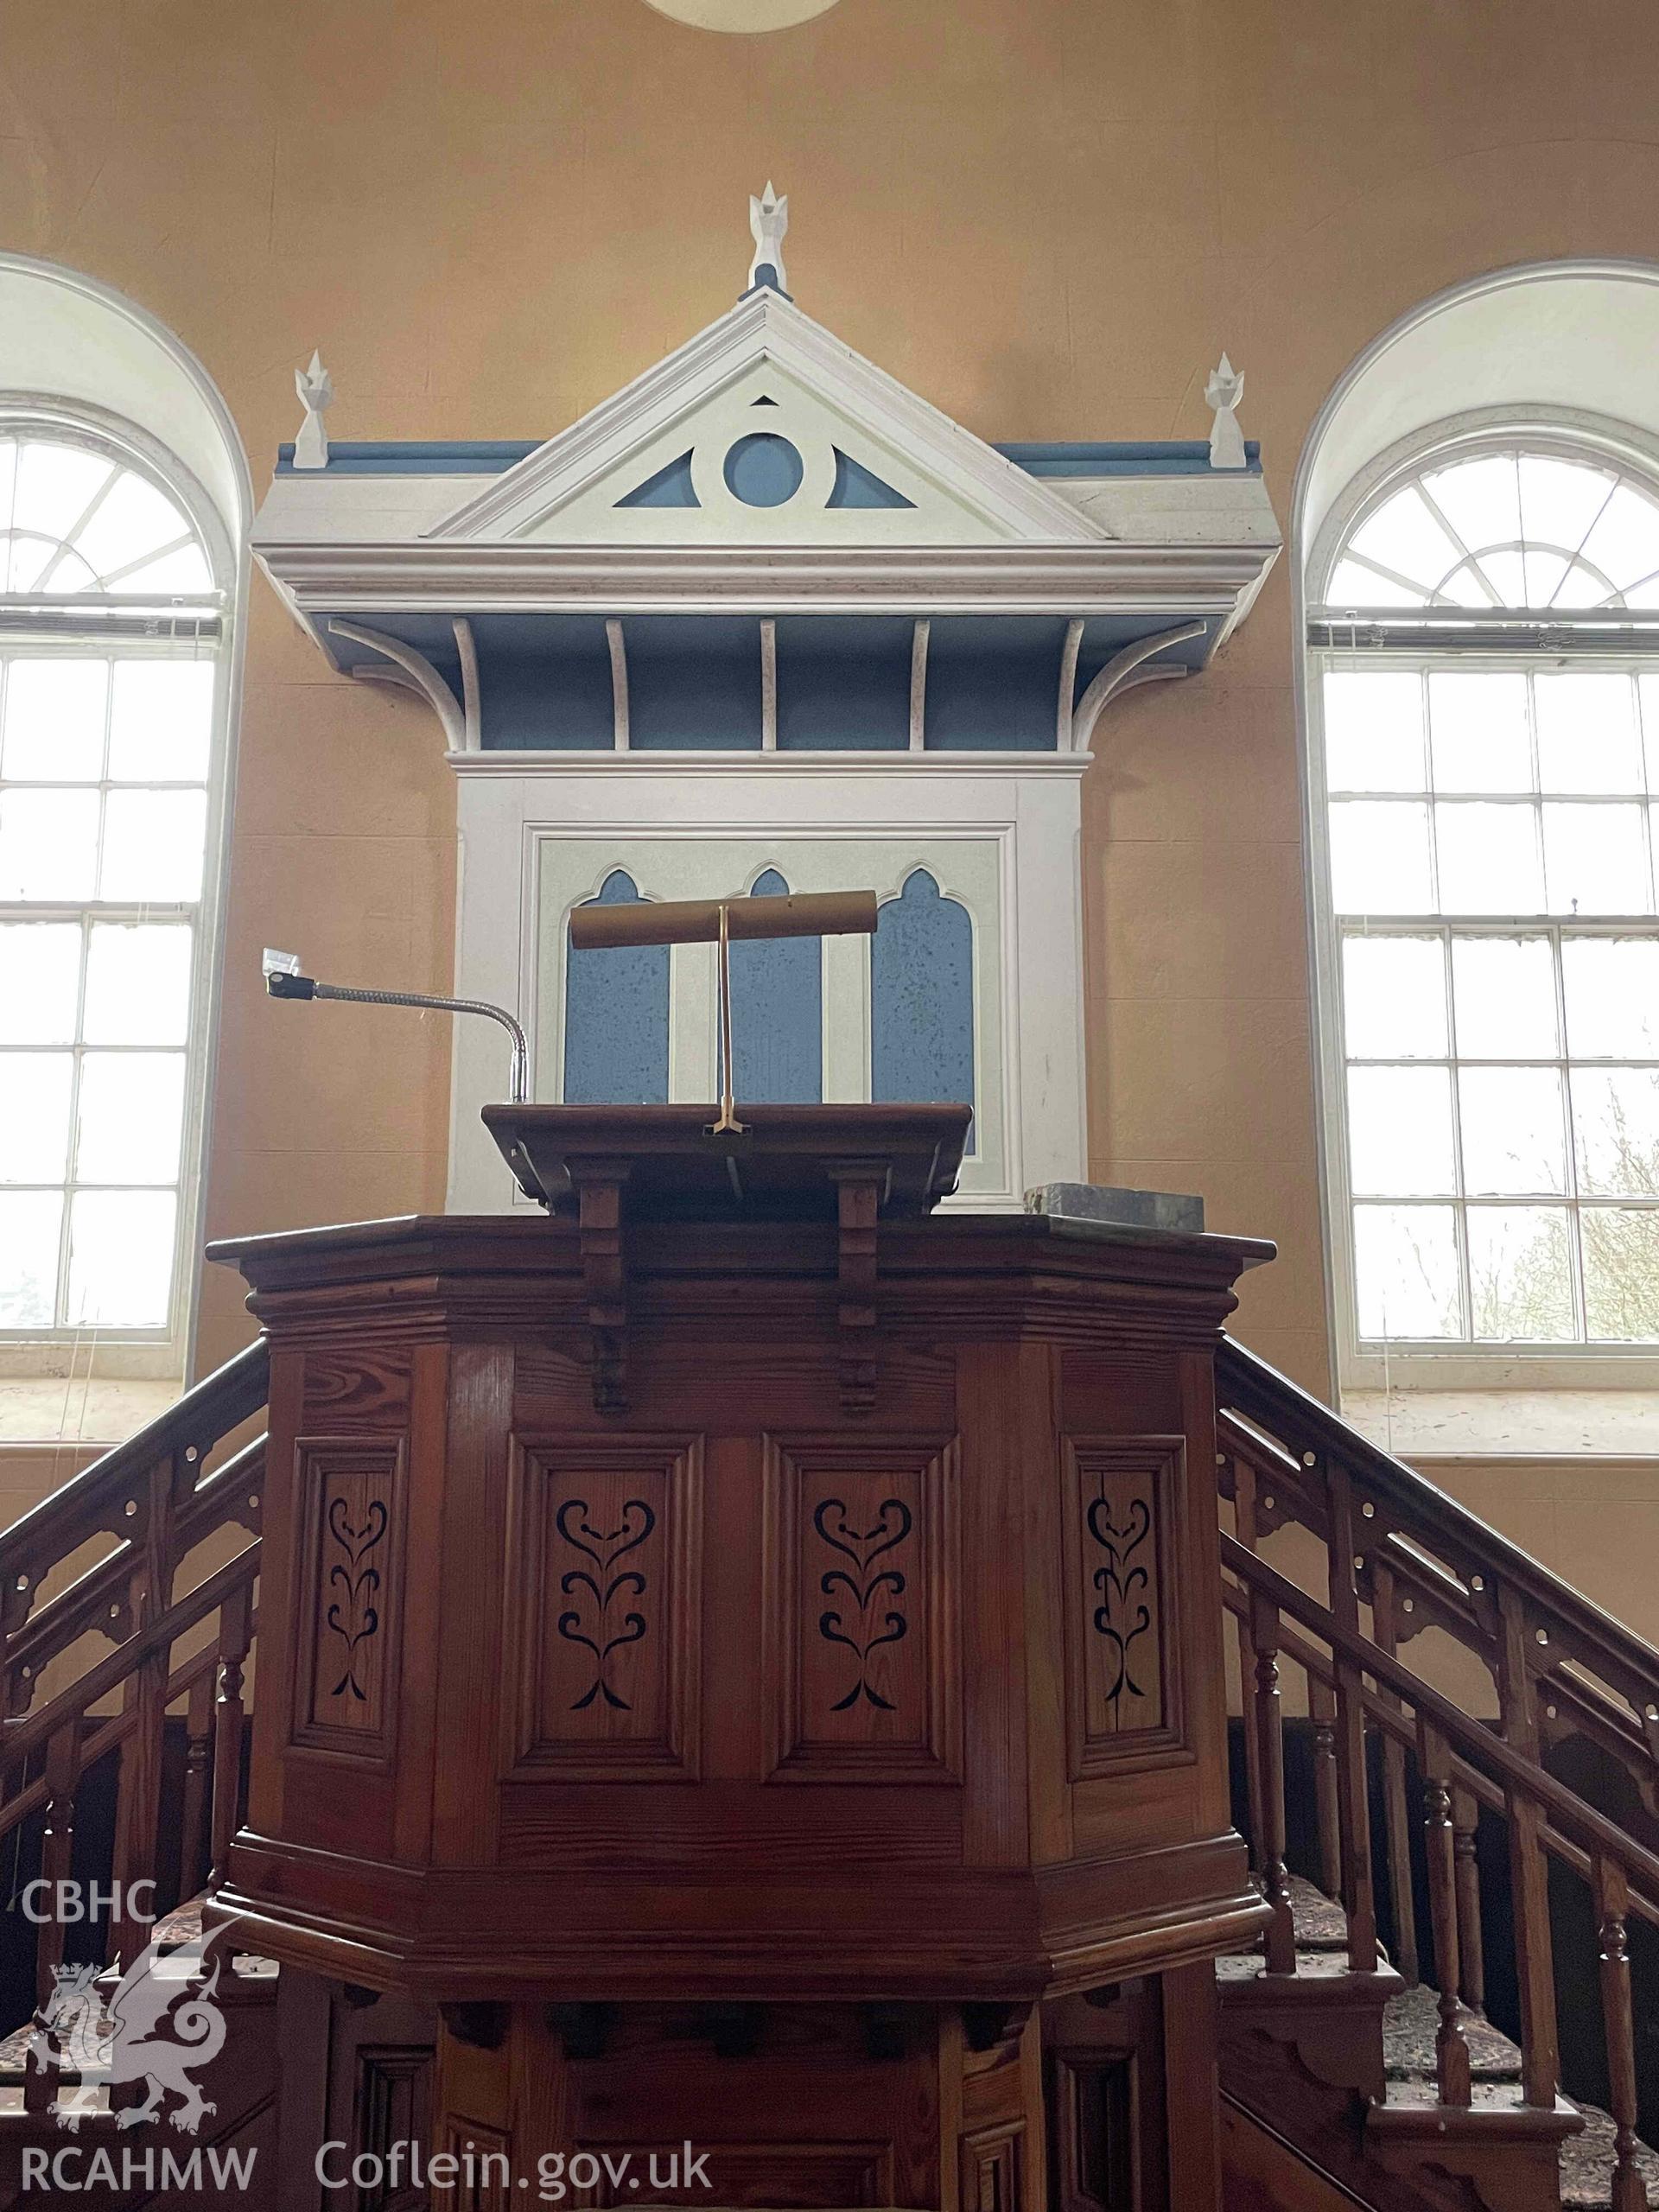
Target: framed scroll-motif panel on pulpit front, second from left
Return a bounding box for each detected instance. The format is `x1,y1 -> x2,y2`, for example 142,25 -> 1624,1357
512,1433 -> 703,1781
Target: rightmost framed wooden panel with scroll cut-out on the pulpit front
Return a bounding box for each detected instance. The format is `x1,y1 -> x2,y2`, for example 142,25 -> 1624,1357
1064,1435 -> 1185,1781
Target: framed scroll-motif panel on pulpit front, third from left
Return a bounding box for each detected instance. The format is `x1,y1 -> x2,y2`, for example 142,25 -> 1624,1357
766,1435 -> 963,1783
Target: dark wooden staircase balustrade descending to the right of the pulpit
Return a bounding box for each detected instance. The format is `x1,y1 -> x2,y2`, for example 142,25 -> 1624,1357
1217,1344 -> 1659,2212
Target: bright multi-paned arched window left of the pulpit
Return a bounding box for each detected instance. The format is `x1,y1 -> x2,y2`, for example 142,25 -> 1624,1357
0,420 -> 237,1336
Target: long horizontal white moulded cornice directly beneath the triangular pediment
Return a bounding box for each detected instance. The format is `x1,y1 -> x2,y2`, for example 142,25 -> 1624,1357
259,540 -> 1279,626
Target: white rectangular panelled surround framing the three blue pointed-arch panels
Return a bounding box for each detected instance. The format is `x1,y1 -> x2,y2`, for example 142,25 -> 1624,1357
449,752 -> 1089,1212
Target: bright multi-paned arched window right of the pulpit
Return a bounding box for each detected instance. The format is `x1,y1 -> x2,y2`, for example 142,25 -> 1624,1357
1307,429 -> 1659,1367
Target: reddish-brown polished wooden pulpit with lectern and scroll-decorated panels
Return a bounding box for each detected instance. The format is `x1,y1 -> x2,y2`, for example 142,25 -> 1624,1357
214,1106 -> 1269,2212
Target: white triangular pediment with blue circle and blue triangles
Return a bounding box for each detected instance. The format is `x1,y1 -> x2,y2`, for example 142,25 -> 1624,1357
427,289 -> 1106,549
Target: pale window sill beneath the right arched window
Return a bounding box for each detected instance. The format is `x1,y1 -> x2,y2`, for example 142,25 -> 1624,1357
1343,1389 -> 1659,1465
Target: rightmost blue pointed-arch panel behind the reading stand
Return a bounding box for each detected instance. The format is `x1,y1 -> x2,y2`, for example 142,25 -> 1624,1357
869,868 -> 973,1106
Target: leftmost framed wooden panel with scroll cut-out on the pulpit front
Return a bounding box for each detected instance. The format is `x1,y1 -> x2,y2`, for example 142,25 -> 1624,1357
292,1435 -> 404,1763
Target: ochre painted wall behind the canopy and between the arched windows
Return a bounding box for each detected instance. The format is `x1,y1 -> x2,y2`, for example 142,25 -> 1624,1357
0,0 -> 1659,1387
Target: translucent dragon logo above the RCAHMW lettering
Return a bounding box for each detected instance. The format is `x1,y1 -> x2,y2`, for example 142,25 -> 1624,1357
29,1929 -> 226,2134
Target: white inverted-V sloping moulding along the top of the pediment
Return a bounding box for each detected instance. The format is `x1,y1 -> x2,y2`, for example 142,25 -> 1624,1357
427,292 -> 1103,544
